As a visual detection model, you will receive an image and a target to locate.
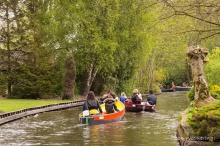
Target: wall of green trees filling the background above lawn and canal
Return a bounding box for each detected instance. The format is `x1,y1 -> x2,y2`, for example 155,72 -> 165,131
0,0 -> 219,98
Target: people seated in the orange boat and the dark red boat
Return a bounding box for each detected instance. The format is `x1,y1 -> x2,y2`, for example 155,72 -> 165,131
83,89 -> 157,114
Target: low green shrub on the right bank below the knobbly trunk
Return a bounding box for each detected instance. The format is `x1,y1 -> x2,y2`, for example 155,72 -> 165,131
188,102 -> 220,137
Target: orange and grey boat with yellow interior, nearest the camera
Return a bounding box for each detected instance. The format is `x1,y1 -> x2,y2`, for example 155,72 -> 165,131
79,100 -> 125,125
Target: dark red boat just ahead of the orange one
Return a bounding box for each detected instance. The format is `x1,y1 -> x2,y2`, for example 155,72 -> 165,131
124,99 -> 155,112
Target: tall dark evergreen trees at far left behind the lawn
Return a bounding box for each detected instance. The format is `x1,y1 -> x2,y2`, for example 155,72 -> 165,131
0,0 -> 63,98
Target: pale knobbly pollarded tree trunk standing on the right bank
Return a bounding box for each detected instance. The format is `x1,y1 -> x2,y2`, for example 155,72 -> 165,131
187,46 -> 214,107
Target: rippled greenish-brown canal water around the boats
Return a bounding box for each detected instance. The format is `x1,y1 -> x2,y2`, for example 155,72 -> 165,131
0,92 -> 189,146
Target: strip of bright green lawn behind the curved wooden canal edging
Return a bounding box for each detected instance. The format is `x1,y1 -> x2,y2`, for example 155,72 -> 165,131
0,98 -> 73,112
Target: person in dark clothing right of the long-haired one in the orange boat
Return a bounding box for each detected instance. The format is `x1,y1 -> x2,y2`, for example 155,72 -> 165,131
103,95 -> 119,114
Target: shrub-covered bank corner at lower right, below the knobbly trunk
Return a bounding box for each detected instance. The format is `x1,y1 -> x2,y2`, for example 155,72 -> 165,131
177,100 -> 220,146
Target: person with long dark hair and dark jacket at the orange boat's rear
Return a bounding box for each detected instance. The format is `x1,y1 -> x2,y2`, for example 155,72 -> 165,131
83,91 -> 102,113
